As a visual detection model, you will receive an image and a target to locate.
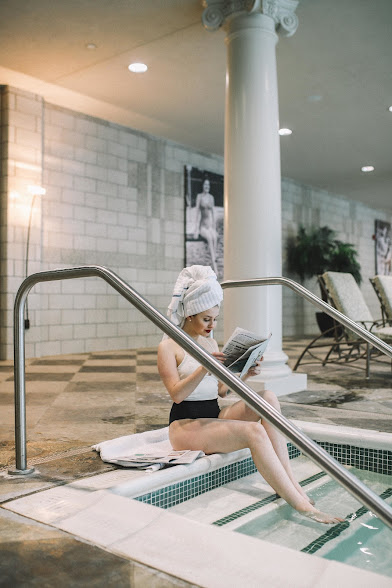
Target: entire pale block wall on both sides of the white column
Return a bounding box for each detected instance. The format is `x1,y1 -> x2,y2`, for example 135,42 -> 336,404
0,87 -> 390,358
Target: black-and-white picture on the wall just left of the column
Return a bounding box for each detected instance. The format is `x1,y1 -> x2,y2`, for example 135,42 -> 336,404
184,165 -> 223,280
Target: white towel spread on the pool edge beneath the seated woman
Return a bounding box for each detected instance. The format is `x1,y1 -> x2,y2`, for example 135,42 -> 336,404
92,427 -> 173,471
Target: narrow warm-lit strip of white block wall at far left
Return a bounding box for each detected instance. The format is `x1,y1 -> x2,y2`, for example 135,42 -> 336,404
0,87 -> 45,358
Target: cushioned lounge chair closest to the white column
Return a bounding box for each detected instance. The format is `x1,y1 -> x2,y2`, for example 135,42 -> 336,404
294,272 -> 392,377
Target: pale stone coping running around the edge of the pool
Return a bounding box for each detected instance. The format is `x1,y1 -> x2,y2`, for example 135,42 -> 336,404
3,421 -> 392,588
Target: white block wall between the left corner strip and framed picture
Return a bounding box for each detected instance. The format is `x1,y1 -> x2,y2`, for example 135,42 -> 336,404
4,95 -> 223,355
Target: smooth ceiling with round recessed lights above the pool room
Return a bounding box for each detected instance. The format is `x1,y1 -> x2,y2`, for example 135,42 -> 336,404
0,0 -> 392,214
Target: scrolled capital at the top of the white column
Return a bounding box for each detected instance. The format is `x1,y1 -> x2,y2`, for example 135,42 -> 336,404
201,0 -> 299,37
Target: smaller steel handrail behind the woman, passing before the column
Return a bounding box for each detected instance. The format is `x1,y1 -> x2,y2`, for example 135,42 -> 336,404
221,277 -> 392,357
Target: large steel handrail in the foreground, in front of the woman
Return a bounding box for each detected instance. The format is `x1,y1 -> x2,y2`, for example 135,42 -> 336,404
10,266 -> 392,528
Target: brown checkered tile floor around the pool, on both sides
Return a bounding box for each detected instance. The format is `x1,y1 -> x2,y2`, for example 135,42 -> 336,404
0,340 -> 392,588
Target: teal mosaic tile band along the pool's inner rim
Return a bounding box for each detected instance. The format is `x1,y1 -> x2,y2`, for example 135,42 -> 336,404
134,441 -> 392,512
